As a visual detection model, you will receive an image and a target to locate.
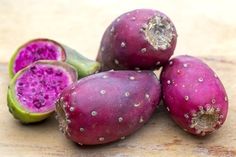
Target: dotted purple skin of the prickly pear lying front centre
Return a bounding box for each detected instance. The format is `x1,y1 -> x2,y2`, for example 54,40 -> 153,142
56,71 -> 161,145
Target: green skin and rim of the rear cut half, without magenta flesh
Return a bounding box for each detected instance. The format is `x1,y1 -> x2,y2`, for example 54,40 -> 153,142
8,38 -> 101,78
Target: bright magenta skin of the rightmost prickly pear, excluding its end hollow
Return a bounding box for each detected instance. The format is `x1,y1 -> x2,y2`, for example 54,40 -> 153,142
160,55 -> 228,136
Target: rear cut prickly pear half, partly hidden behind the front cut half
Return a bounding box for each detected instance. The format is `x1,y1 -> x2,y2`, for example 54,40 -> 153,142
9,38 -> 100,78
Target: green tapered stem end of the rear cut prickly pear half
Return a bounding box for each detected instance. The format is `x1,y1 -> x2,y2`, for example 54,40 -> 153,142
63,45 -> 101,78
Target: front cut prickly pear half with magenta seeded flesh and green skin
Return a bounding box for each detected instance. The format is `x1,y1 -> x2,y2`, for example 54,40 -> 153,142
7,61 -> 77,123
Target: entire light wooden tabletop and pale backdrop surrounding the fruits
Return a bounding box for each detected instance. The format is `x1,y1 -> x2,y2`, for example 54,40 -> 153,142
0,0 -> 236,157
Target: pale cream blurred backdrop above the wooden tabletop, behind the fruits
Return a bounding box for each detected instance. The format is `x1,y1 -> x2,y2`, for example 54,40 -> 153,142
0,0 -> 236,63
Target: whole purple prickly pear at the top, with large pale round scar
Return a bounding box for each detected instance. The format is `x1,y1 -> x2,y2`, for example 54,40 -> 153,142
97,9 -> 177,71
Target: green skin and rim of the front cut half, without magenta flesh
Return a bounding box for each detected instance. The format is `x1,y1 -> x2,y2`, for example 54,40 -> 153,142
7,60 -> 78,124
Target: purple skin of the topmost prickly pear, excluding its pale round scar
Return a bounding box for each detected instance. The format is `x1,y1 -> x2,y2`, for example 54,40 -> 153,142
97,9 -> 177,71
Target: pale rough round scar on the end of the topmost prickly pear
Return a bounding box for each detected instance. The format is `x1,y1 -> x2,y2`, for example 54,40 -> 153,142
142,15 -> 175,50
